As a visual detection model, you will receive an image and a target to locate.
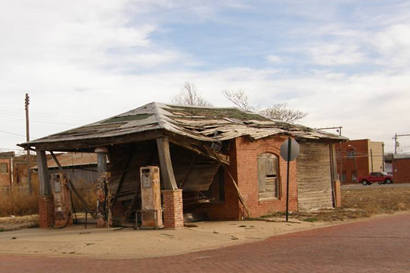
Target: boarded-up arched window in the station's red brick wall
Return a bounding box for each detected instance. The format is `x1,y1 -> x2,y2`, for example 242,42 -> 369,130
258,153 -> 280,199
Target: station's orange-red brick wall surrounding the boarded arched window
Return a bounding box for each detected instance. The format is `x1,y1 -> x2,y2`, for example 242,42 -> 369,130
208,136 -> 297,219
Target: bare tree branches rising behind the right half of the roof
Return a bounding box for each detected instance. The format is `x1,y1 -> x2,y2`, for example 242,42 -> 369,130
222,90 -> 307,122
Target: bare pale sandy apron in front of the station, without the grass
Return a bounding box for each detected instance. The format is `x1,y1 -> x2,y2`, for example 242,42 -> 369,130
0,215 -> 334,258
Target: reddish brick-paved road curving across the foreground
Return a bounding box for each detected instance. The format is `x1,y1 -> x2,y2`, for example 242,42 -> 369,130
0,214 -> 410,273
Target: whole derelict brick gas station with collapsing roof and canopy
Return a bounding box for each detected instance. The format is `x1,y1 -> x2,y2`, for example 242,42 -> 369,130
20,102 -> 346,228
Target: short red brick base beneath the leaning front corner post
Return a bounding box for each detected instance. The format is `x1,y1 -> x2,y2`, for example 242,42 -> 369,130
162,190 -> 184,229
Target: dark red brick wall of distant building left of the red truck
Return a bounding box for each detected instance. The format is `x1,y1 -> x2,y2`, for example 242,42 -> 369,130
336,139 -> 370,184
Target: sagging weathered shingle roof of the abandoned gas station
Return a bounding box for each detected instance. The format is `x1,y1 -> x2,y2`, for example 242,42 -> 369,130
20,102 -> 346,146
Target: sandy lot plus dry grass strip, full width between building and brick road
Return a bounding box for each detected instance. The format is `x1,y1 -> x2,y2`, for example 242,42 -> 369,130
0,183 -> 410,259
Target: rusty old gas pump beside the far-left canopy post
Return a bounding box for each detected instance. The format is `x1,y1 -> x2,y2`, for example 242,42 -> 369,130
50,173 -> 73,228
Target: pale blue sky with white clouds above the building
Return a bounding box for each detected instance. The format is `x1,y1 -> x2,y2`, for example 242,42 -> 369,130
0,0 -> 410,152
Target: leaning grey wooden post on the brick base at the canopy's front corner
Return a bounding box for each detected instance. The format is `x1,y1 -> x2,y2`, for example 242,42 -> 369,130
157,137 -> 178,190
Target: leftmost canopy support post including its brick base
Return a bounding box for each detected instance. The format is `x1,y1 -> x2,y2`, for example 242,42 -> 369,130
36,150 -> 54,228
